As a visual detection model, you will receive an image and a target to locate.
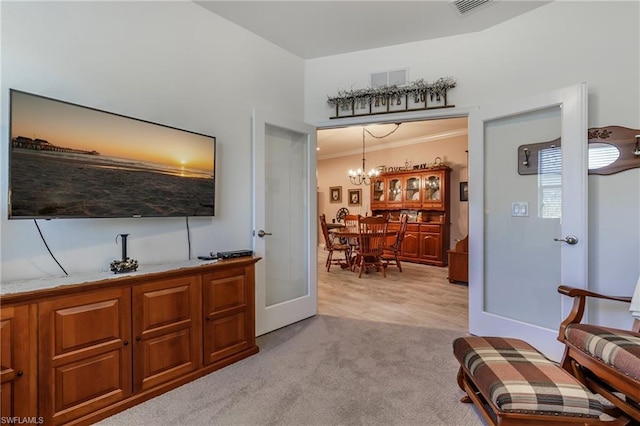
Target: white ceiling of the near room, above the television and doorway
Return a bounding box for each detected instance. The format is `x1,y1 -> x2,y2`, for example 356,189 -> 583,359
195,0 -> 550,59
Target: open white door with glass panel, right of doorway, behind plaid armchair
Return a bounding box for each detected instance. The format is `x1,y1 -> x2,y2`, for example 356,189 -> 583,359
469,84 -> 587,360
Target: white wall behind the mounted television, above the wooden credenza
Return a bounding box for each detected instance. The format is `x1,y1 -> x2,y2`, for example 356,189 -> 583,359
0,1 -> 304,282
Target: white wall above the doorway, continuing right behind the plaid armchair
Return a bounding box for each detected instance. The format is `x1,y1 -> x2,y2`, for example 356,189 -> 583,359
305,1 -> 640,326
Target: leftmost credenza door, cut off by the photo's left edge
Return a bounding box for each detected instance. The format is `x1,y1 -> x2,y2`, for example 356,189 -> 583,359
0,304 -> 38,418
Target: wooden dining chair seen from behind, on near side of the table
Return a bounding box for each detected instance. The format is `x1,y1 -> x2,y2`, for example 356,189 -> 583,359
354,216 -> 388,278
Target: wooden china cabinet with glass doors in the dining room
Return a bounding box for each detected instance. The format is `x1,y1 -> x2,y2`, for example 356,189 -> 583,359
371,166 -> 451,266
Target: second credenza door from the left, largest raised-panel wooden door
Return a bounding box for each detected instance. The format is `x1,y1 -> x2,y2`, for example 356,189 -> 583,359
38,287 -> 132,424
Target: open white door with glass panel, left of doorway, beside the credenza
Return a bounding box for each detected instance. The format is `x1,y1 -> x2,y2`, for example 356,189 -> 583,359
253,110 -> 318,336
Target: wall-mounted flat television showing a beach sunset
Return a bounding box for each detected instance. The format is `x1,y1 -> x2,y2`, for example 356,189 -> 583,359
9,89 -> 216,219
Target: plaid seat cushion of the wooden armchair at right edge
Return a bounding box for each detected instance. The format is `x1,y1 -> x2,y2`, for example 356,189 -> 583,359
565,324 -> 640,381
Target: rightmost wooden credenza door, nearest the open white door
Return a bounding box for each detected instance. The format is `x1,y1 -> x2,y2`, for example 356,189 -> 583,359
202,267 -> 255,364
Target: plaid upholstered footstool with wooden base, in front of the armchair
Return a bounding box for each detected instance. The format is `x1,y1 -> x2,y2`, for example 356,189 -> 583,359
453,337 -> 603,425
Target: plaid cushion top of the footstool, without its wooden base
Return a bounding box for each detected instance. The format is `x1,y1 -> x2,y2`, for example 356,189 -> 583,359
453,336 -> 602,418
